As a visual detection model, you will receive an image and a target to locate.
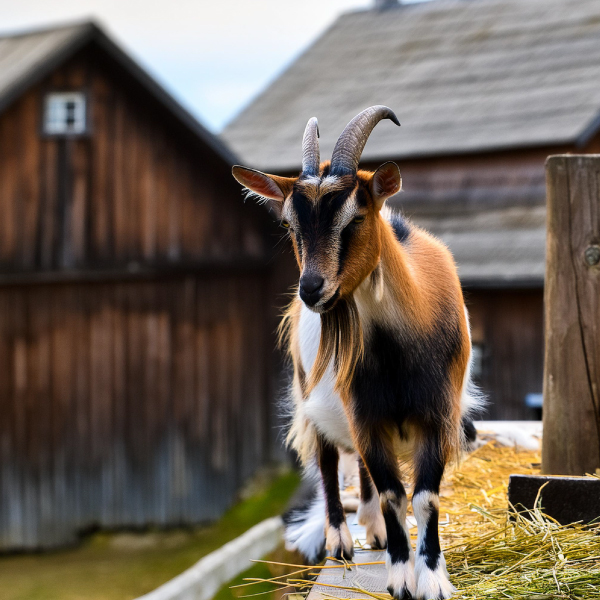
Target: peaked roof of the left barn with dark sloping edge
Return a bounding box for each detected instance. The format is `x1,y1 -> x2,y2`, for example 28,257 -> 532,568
0,21 -> 236,164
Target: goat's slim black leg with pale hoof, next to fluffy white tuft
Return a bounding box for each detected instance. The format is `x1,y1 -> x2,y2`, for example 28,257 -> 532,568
317,434 -> 354,560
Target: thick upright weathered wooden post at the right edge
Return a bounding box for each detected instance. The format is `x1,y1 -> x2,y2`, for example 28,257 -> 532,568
542,155 -> 600,475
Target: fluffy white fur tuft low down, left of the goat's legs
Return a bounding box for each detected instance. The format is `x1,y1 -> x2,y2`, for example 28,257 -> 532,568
283,469 -> 326,564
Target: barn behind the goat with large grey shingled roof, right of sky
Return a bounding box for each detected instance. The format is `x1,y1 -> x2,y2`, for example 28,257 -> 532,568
222,0 -> 600,419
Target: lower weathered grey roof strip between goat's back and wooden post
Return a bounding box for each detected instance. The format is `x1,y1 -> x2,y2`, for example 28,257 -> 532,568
390,183 -> 546,287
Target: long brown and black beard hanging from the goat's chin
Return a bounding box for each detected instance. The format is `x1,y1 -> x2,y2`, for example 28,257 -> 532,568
306,297 -> 364,396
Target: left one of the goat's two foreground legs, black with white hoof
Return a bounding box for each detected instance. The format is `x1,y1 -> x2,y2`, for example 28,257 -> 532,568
355,427 -> 417,600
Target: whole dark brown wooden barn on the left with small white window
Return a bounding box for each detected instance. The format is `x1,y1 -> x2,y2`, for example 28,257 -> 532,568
0,23 -> 274,550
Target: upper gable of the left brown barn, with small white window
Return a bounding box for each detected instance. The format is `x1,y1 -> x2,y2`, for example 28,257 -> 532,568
0,23 -> 266,280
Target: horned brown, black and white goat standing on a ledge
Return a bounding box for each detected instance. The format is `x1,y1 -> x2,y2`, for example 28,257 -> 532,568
233,106 -> 478,600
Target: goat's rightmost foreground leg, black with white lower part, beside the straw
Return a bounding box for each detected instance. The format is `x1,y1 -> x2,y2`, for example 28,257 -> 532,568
412,433 -> 456,600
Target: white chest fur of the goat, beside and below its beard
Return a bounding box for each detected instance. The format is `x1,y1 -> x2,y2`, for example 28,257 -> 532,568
299,306 -> 353,450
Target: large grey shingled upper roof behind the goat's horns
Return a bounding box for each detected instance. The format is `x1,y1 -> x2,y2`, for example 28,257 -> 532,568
222,0 -> 600,171
